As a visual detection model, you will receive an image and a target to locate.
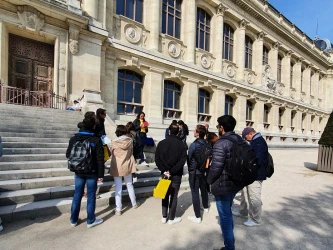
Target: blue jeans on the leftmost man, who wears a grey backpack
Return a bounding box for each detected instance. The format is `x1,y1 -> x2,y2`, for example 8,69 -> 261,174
70,174 -> 97,224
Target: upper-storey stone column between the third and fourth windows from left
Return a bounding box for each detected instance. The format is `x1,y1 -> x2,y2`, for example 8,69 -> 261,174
213,3 -> 228,72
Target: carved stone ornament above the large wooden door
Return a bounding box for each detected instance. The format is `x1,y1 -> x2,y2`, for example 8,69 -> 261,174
17,5 -> 44,32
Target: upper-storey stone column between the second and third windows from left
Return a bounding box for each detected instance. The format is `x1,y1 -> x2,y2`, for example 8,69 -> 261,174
183,1 -> 197,64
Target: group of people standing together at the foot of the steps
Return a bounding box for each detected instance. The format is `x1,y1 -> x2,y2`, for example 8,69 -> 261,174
66,109 -> 268,250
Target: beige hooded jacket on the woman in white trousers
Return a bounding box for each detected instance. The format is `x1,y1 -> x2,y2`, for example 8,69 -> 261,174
110,135 -> 136,177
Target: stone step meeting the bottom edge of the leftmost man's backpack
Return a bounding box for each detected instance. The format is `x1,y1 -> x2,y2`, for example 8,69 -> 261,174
0,161 -> 67,171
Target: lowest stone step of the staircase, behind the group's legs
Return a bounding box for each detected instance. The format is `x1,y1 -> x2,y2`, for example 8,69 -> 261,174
0,181 -> 189,222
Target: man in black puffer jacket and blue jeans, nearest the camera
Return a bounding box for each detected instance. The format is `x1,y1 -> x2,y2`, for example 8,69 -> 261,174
207,115 -> 243,250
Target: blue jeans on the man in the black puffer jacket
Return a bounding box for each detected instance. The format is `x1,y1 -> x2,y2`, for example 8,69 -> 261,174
215,193 -> 236,250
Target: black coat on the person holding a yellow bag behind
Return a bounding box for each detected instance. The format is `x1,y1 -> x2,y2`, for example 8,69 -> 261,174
155,135 -> 187,176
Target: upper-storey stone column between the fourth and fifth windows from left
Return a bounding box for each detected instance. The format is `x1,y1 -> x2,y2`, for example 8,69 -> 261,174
235,19 -> 249,81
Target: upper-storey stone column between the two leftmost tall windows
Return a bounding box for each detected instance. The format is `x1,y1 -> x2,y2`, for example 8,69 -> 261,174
146,0 -> 162,51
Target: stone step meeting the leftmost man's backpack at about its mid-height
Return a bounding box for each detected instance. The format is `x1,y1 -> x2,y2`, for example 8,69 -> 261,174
0,154 -> 66,162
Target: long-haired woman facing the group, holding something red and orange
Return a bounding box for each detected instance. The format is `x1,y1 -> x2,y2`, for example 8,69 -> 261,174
133,111 -> 149,166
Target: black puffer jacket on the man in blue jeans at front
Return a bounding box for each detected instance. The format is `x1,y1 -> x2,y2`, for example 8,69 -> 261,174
207,132 -> 243,195
